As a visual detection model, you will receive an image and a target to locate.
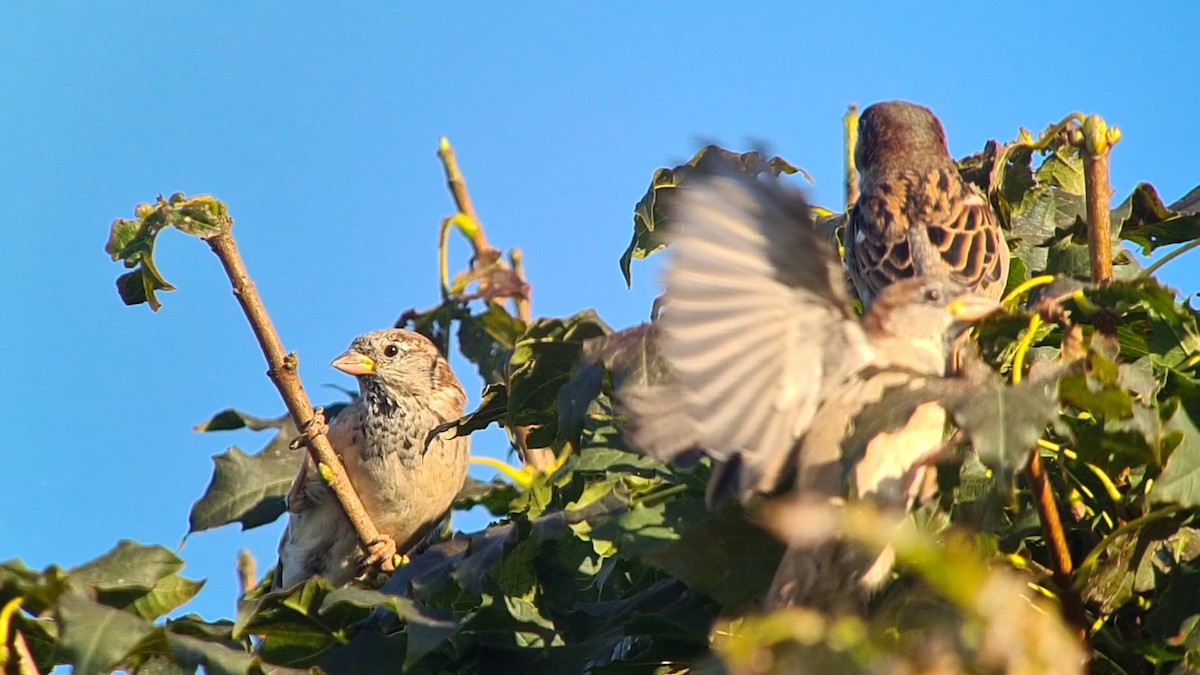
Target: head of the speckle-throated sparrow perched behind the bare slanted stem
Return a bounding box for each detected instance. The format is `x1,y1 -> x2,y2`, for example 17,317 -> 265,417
330,328 -> 466,401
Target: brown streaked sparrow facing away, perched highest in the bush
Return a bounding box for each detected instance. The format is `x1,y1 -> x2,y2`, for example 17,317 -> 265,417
844,101 -> 1008,306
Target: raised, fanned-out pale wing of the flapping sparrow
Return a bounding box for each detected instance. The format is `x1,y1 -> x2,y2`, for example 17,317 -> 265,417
622,165 -> 870,492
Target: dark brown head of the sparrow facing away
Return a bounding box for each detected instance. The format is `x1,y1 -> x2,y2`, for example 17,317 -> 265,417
854,101 -> 950,175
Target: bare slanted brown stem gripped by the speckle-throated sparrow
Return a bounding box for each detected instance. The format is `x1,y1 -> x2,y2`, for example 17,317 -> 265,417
208,231 -> 395,572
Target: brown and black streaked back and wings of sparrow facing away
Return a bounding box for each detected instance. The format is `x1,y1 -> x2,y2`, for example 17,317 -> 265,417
846,167 -> 1008,304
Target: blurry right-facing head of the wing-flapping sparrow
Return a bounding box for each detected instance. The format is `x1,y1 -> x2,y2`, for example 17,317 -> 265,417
863,277 -> 1000,364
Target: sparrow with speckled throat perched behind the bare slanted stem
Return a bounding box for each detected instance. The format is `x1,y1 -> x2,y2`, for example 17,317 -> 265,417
272,329 -> 470,589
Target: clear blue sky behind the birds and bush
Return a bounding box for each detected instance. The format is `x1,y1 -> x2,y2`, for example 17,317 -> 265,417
0,1 -> 1200,619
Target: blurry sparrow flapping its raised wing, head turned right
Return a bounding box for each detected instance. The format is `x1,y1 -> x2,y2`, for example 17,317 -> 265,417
622,158 -> 998,607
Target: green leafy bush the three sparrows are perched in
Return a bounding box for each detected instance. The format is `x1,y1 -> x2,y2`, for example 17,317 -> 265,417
0,117 -> 1200,674
